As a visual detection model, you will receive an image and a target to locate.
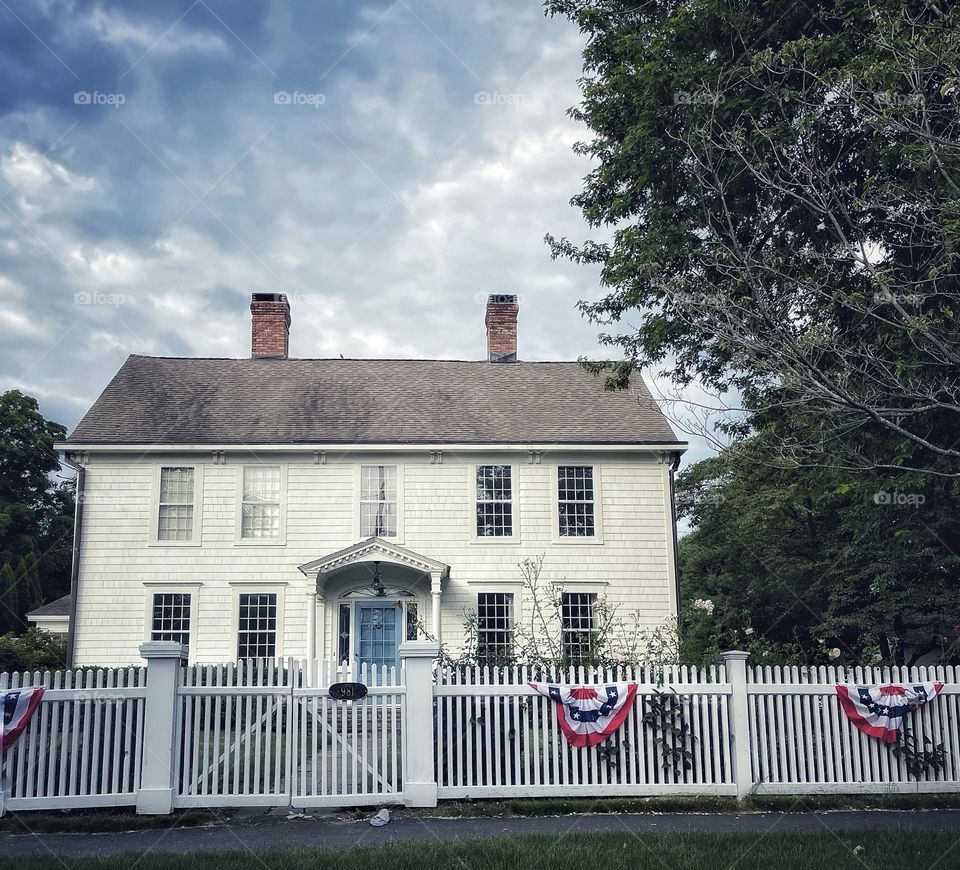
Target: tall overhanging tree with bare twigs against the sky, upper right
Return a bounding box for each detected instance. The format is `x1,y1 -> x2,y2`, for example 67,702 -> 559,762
546,0 -> 960,476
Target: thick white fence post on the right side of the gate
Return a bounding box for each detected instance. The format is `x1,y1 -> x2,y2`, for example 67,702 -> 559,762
399,640 -> 440,807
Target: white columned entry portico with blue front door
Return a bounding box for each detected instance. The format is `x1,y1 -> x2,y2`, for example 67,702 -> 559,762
299,537 -> 450,666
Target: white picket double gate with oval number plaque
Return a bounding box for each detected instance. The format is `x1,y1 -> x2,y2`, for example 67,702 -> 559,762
175,659 -> 406,807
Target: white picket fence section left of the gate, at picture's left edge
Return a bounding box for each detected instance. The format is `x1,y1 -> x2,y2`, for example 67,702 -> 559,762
0,668 -> 146,810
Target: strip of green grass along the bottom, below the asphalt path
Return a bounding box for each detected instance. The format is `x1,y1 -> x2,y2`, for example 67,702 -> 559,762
47,830 -> 960,870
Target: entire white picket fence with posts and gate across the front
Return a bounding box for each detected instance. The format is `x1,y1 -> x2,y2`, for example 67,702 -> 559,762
0,642 -> 960,813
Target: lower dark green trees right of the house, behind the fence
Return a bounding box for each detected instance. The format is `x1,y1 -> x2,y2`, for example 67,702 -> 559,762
677,450 -> 960,664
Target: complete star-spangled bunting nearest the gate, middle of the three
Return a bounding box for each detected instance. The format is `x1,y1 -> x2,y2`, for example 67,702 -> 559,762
530,683 -> 637,746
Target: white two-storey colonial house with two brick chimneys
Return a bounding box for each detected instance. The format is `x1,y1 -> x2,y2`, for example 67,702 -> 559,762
52,293 -> 686,665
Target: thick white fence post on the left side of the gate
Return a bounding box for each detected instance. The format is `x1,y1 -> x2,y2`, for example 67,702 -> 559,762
137,640 -> 187,815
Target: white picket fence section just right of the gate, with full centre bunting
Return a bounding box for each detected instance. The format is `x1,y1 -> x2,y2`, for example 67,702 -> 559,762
435,667 -> 736,798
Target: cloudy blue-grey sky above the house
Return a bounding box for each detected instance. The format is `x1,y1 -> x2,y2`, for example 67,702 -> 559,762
0,0 -> 700,466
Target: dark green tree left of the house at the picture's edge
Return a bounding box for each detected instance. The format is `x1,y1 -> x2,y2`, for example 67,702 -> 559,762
0,390 -> 74,633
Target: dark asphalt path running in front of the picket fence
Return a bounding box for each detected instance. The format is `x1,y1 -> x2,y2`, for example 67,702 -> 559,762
0,810 -> 960,857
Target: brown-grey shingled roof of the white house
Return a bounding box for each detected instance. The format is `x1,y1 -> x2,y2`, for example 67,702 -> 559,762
66,356 -> 682,446
